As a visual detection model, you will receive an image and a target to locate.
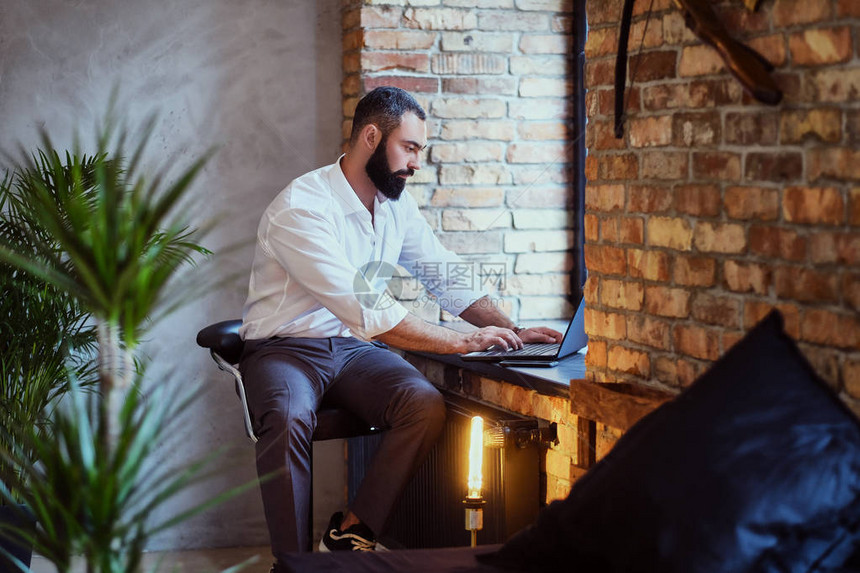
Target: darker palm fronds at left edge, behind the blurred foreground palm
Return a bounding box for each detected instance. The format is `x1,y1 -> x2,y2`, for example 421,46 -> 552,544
0,156 -> 95,571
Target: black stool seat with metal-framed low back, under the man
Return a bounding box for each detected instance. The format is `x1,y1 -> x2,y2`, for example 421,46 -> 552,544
197,319 -> 379,443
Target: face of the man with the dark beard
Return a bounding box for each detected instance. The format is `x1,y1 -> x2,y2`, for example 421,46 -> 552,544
364,113 -> 427,201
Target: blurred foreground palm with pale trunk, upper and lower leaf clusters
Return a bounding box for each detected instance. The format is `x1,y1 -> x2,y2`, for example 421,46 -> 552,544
0,108 -> 252,573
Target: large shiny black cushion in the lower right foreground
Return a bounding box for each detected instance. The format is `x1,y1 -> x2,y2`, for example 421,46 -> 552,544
480,312 -> 860,573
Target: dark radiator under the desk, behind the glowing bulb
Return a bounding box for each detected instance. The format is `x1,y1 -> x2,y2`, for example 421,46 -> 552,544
347,395 -> 554,548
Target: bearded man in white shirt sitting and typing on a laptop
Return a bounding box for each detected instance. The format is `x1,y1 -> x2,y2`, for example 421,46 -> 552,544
240,87 -> 561,571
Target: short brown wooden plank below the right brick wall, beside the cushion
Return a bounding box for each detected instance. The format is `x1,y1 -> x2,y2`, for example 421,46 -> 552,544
570,380 -> 675,431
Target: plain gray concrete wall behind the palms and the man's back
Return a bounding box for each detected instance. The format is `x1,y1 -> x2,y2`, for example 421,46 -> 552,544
0,0 -> 343,549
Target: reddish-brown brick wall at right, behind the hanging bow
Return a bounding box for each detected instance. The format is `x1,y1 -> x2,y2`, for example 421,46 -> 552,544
585,0 -> 860,412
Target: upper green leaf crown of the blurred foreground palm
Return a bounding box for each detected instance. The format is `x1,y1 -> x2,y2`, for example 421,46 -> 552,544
0,119 -> 211,346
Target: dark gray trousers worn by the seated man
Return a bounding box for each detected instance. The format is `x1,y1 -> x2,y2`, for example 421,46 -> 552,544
239,338 -> 445,559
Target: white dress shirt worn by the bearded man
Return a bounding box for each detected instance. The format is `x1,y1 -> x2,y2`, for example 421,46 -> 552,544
239,156 -> 482,340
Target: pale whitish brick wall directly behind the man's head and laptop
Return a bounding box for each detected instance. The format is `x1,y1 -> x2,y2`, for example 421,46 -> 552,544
343,0 -> 574,320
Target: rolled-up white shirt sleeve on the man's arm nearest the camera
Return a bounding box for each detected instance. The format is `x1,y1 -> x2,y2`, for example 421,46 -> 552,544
258,208 -> 408,340
